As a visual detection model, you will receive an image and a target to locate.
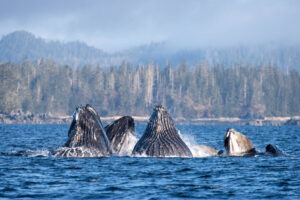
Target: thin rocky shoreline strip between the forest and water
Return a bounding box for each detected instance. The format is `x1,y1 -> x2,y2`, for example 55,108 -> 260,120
0,111 -> 300,126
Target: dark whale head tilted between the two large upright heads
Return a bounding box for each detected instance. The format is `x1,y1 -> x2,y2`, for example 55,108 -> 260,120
104,116 -> 138,155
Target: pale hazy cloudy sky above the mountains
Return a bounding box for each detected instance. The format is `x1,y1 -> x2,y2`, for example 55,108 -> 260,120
0,0 -> 300,51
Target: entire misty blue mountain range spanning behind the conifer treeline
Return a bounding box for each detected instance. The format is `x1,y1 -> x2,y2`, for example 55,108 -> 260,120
0,31 -> 300,71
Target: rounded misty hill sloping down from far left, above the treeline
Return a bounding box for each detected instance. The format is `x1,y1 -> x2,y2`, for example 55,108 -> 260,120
0,31 -> 108,65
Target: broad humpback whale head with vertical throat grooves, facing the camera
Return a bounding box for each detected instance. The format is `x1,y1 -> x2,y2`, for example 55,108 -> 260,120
132,106 -> 193,157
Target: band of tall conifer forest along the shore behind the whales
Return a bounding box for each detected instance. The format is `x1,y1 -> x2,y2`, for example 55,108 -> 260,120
0,59 -> 300,118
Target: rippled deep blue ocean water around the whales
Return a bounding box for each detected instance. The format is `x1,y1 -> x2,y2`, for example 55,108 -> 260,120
0,125 -> 300,199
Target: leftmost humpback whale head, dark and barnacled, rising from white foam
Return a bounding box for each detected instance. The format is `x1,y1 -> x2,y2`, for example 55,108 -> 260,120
54,104 -> 112,157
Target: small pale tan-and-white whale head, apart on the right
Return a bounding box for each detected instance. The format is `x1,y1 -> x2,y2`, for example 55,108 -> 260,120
224,128 -> 257,156
